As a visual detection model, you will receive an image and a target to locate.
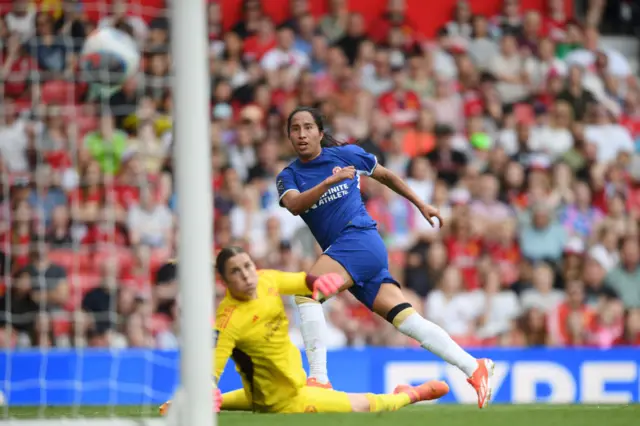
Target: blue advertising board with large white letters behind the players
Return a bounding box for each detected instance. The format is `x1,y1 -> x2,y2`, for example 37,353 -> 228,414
0,348 -> 640,405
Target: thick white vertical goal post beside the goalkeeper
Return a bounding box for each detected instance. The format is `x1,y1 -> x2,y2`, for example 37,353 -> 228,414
167,0 -> 215,426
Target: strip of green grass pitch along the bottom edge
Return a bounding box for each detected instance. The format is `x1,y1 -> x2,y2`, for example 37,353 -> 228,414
0,404 -> 640,426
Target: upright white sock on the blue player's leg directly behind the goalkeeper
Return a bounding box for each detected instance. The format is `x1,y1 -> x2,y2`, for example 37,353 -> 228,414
295,296 -> 329,383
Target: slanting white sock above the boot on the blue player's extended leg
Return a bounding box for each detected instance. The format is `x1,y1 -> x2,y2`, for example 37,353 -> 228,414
397,312 -> 478,377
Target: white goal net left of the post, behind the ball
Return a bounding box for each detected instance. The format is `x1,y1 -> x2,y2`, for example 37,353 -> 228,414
0,0 -> 208,426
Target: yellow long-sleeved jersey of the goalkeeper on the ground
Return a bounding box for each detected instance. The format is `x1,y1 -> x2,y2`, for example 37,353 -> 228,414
214,270 -> 311,412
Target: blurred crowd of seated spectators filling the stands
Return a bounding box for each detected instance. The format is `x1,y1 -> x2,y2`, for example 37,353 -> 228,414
0,0 -> 640,348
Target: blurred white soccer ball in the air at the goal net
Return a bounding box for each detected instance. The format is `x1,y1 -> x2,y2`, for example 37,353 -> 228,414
80,28 -> 140,89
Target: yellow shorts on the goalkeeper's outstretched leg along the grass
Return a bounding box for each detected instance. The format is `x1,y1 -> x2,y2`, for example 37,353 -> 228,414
277,386 -> 352,413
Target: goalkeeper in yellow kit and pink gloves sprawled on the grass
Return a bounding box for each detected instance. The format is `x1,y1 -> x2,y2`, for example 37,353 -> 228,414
160,247 -> 449,413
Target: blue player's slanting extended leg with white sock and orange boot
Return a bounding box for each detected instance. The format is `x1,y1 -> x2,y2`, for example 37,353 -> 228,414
368,282 -> 494,408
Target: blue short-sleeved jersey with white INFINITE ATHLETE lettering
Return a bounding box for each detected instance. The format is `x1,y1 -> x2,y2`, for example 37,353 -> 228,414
276,145 -> 378,250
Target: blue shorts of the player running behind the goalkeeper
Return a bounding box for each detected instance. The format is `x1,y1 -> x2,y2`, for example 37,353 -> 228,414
324,227 -> 400,309
